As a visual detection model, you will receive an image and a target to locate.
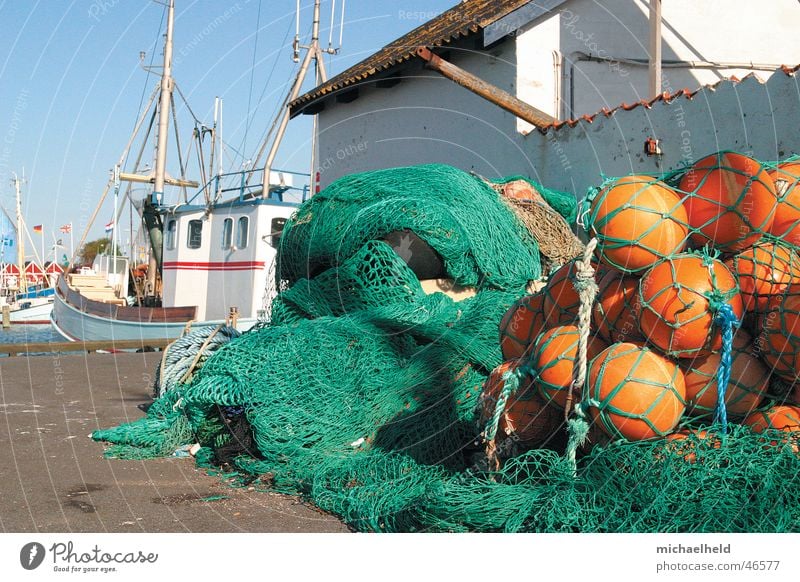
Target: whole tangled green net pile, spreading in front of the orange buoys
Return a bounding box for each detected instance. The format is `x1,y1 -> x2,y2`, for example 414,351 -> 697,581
93,165 -> 800,532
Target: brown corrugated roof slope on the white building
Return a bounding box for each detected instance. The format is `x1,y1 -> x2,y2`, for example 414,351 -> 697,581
289,0 -> 530,116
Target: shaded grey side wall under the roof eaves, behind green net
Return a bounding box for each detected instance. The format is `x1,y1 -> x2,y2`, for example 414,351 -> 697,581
318,37 -> 523,188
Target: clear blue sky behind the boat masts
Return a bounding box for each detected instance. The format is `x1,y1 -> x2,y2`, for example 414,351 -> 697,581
0,0 -> 456,253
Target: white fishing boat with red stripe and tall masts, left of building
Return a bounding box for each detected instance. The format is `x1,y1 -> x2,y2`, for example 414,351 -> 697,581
51,0 -> 338,341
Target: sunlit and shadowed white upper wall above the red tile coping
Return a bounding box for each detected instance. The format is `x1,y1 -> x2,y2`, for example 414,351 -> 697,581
517,0 -> 800,122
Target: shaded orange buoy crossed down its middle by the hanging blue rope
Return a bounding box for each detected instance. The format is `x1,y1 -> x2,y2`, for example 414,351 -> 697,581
678,331 -> 770,417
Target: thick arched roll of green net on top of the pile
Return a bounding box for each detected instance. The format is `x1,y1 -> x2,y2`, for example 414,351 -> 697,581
278,165 -> 564,289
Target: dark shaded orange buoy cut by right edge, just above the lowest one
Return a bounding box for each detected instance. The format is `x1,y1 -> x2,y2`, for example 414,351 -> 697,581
756,285 -> 800,384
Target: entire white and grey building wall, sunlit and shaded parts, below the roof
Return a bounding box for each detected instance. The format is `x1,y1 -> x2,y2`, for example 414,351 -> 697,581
312,0 -> 800,197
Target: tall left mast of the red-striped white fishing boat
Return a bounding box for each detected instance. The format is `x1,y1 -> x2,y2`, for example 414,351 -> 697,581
143,0 -> 175,297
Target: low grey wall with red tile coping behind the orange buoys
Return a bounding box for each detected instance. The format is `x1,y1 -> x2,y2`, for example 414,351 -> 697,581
521,71 -> 800,198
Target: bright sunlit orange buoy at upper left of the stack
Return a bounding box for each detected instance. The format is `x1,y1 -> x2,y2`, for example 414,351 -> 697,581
589,175 -> 688,272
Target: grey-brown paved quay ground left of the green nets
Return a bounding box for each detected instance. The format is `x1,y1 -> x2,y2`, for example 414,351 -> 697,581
0,352 -> 347,533
